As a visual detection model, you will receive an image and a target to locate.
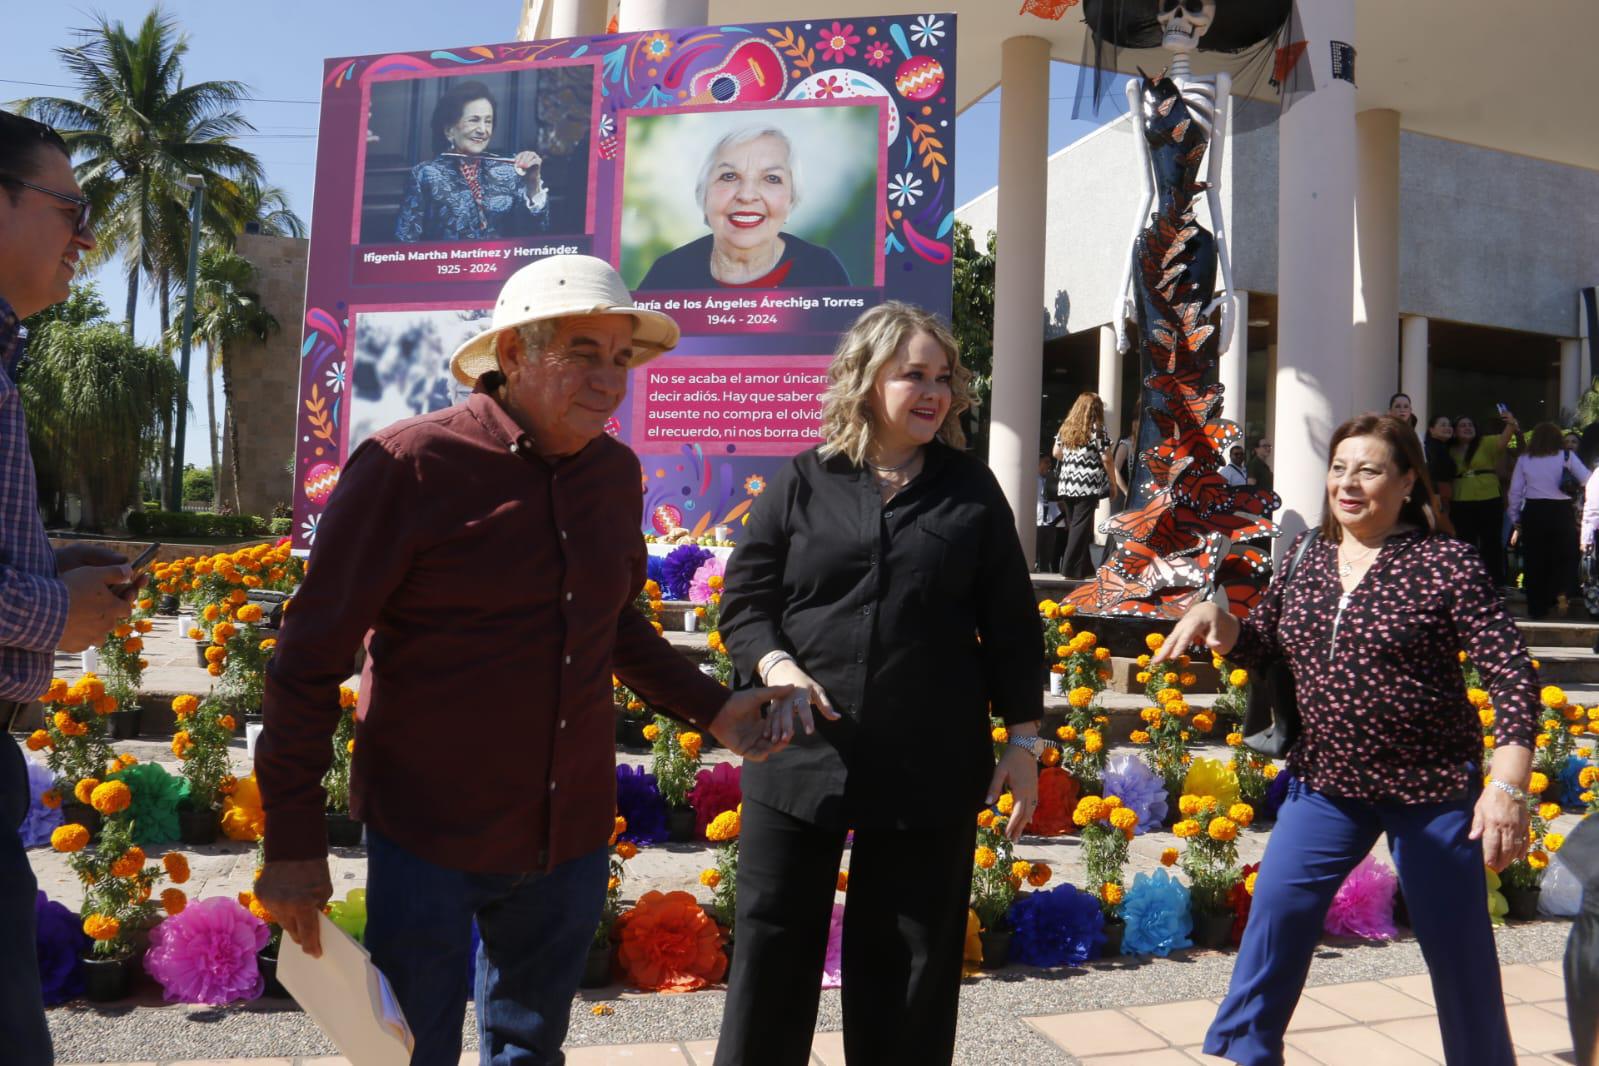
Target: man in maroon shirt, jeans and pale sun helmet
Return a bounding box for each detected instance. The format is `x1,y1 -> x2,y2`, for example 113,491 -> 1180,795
256,256 -> 792,1064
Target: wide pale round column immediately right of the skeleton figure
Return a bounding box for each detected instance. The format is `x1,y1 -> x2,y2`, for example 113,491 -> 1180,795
1271,0 -> 1356,555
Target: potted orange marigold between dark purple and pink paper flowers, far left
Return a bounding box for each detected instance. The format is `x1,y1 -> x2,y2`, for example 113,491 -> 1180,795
50,782 -> 189,1002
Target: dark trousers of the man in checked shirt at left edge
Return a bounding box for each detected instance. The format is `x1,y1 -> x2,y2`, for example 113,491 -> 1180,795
0,737 -> 56,1066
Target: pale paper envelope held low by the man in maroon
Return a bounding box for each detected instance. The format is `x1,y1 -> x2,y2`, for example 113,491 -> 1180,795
278,914 -> 416,1066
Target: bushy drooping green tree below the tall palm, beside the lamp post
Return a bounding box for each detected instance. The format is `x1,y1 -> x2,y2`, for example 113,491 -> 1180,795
19,319 -> 177,529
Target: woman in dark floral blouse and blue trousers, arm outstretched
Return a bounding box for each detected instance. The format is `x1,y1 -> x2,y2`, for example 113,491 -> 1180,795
1158,416 -> 1538,1066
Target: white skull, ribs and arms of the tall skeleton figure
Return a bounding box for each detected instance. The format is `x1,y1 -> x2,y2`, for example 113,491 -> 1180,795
1111,0 -> 1238,361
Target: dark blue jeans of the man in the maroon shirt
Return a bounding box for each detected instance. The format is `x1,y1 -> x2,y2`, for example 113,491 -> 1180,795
366,826 -> 609,1066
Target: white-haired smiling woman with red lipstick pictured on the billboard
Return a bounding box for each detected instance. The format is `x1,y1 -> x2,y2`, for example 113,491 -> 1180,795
638,126 -> 849,289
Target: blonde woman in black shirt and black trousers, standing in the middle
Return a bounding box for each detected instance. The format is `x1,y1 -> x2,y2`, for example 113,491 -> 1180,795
716,302 -> 1043,1066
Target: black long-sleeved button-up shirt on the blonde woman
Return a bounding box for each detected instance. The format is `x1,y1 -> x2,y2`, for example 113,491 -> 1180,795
721,444 -> 1043,825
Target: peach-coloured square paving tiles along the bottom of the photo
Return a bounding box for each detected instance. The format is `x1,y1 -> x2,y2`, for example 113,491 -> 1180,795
59,961 -> 1575,1066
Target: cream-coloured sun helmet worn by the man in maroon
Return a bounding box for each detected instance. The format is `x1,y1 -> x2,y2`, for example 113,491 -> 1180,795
449,256 -> 678,385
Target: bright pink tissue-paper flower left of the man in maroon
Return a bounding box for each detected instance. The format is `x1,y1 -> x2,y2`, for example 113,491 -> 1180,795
144,897 -> 272,1005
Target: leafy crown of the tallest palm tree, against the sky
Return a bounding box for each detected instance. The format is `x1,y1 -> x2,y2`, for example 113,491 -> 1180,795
19,8 -> 262,336
